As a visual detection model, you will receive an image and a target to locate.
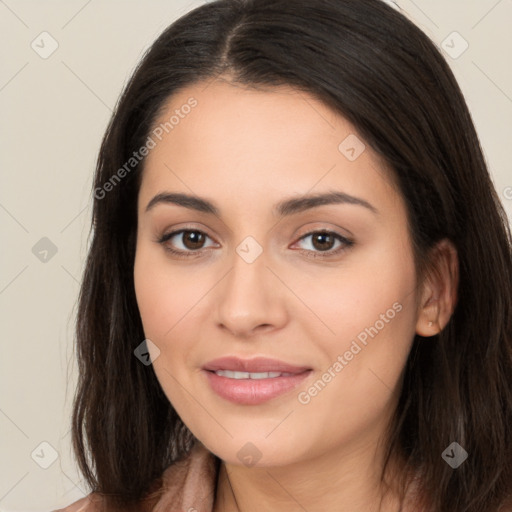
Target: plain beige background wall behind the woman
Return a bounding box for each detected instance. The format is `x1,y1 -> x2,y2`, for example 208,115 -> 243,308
0,0 -> 512,511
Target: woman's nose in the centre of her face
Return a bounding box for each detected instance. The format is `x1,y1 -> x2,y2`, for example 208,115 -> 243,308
215,245 -> 290,338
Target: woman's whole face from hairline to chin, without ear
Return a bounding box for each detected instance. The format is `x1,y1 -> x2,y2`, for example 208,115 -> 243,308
134,81 -> 417,467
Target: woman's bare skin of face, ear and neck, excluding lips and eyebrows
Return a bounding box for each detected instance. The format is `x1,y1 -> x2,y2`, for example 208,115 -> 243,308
134,80 -> 457,512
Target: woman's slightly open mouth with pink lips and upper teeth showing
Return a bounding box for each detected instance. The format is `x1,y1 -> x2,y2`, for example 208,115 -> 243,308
202,357 -> 313,405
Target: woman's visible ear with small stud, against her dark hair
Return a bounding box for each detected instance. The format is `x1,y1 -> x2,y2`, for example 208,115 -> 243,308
416,238 -> 459,337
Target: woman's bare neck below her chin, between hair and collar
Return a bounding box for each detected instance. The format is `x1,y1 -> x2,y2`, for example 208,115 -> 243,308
214,434 -> 408,512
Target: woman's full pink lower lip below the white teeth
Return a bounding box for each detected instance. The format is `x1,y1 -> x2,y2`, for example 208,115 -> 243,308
203,370 -> 312,405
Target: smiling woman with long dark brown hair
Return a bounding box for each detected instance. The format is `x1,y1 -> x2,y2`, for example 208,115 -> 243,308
54,0 -> 512,512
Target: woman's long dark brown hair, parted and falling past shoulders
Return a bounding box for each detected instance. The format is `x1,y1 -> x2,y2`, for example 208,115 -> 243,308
72,0 -> 512,512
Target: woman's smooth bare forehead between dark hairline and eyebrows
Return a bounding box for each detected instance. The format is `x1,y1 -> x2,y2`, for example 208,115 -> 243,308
140,81 -> 402,218
